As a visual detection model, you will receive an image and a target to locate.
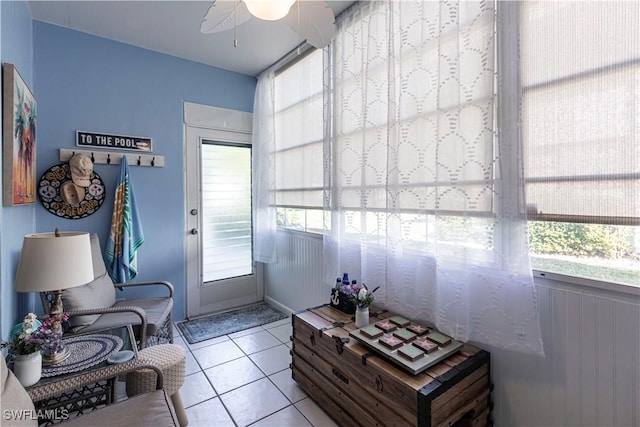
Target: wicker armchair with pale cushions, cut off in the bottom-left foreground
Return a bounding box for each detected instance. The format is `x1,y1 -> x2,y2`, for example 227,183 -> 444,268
0,357 -> 179,427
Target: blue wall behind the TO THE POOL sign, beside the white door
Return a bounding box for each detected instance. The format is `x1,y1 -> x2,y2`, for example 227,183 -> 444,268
26,21 -> 256,319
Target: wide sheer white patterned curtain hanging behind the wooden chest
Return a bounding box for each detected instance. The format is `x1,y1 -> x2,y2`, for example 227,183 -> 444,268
324,1 -> 543,354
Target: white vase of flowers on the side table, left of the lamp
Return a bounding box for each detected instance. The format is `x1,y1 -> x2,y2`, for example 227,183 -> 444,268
2,313 -> 47,387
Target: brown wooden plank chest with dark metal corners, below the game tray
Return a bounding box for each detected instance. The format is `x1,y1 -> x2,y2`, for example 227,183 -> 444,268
291,305 -> 491,427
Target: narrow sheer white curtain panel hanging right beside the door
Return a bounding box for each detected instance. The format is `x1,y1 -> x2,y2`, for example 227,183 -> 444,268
251,68 -> 276,263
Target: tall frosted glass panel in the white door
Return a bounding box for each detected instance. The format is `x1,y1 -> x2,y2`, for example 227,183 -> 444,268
201,141 -> 253,283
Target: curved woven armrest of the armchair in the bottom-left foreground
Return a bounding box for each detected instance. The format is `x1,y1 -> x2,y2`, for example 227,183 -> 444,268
27,358 -> 164,402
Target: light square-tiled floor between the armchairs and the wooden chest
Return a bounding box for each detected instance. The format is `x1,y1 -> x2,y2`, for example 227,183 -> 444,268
174,318 -> 337,427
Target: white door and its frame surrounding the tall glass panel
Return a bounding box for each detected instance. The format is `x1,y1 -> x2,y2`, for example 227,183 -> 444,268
183,102 -> 264,318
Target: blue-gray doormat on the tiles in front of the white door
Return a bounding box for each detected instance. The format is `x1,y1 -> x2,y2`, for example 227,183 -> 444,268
177,302 -> 287,344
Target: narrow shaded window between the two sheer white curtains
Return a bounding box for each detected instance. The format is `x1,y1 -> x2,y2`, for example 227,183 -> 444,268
274,50 -> 324,233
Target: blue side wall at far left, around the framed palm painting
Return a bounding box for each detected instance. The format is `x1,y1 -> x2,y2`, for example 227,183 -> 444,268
0,1 -> 40,339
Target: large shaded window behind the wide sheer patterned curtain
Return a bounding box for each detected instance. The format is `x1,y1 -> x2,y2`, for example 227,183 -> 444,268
331,2 -> 496,262
